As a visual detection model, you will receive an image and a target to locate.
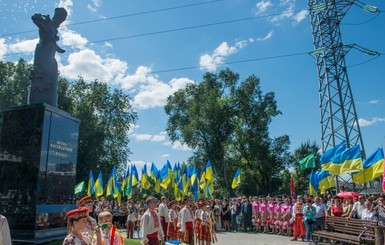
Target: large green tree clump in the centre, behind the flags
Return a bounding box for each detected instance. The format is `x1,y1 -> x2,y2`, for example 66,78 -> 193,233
165,69 -> 290,194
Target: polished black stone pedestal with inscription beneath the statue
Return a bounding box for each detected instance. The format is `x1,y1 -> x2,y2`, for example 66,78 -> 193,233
0,104 -> 80,243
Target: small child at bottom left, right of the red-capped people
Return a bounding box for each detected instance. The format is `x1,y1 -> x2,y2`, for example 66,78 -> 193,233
98,211 -> 123,245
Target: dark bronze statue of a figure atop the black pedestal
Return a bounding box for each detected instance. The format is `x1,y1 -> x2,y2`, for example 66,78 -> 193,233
28,8 -> 67,106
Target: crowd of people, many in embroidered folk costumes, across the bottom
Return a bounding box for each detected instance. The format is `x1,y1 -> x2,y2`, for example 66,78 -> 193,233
0,189 -> 370,245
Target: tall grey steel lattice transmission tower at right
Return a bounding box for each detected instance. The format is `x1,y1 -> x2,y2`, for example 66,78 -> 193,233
308,0 -> 365,156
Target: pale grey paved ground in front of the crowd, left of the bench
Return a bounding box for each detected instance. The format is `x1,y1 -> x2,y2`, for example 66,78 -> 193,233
122,231 -> 327,245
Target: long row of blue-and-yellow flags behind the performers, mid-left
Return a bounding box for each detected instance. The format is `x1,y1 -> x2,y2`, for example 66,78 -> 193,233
75,160 -> 241,202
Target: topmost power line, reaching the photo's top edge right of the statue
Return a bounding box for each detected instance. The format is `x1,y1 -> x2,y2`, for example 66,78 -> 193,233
0,0 -> 224,37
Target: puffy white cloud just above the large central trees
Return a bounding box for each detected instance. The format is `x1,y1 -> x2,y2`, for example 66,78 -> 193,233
199,39 -> 250,72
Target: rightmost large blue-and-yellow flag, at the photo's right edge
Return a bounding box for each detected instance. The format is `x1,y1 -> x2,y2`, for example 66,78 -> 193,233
352,148 -> 384,184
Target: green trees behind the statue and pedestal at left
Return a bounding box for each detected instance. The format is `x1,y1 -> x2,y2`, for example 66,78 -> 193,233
0,60 -> 137,181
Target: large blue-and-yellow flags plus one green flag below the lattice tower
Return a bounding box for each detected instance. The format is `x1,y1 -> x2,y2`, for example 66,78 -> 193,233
300,141 -> 385,196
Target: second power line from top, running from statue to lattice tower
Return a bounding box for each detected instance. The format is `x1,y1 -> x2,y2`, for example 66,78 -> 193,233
3,10 -> 301,56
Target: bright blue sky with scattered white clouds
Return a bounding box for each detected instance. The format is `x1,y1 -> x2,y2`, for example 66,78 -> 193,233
0,0 -> 385,171
